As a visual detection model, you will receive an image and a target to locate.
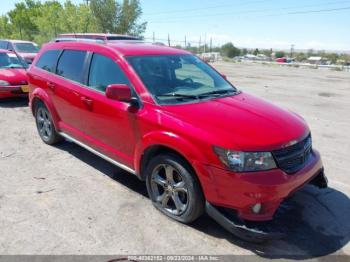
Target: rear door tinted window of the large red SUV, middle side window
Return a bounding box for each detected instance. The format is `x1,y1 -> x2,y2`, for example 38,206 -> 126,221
56,50 -> 86,83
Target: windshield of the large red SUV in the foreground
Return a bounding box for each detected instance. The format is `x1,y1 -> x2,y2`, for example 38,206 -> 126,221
127,55 -> 237,104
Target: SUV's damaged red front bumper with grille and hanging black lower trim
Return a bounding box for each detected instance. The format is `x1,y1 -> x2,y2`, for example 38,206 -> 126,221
202,136 -> 327,242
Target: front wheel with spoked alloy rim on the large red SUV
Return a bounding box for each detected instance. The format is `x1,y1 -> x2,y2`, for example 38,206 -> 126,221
146,153 -> 205,224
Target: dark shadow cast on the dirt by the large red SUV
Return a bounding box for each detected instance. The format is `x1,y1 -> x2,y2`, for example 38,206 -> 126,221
57,142 -> 350,260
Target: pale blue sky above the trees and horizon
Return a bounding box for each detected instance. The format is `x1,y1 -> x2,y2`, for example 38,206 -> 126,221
0,0 -> 350,51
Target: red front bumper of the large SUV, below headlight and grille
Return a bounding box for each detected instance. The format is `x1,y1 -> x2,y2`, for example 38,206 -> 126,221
194,150 -> 323,221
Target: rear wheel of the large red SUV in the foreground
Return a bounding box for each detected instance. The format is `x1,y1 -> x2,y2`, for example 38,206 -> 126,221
35,102 -> 62,145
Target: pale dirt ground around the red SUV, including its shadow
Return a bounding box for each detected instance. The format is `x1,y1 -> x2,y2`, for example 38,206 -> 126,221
0,62 -> 350,259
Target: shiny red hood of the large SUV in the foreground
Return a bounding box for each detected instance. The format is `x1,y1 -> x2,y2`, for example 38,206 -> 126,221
163,93 -> 309,151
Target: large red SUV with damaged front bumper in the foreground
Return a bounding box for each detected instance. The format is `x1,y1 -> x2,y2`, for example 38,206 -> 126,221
28,41 -> 327,242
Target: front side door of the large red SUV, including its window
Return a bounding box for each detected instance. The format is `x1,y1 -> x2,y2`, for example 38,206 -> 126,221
75,53 -> 137,167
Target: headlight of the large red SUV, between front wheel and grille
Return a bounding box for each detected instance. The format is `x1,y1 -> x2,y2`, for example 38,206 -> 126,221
214,146 -> 276,172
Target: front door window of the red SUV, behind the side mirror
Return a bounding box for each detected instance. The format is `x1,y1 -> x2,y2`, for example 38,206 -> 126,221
88,54 -> 129,92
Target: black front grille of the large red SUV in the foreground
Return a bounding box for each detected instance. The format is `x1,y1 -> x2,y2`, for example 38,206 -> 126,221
272,135 -> 312,174
